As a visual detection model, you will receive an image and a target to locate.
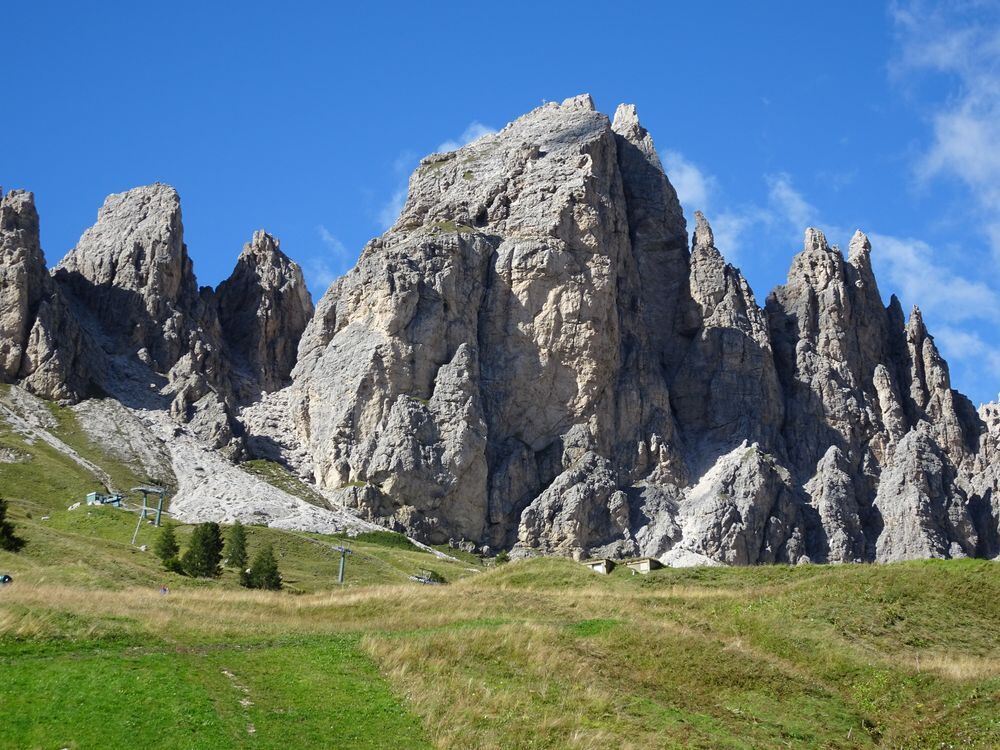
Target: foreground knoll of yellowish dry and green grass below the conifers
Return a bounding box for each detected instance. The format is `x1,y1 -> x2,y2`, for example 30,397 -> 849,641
0,556 -> 1000,748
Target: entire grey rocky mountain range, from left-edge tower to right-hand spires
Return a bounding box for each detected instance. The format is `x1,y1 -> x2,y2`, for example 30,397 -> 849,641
0,96 -> 1000,564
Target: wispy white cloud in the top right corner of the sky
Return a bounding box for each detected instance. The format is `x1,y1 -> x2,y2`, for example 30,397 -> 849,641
891,0 -> 1000,261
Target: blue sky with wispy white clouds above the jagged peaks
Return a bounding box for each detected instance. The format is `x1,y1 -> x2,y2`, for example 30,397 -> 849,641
0,0 -> 1000,402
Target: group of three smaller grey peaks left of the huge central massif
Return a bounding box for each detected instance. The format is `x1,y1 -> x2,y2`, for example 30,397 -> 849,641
0,184 -> 312,456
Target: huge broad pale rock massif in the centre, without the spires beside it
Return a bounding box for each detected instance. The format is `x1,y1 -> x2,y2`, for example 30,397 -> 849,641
293,97 -> 687,548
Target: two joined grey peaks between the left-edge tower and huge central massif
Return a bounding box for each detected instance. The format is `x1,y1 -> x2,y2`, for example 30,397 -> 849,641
41,183 -> 312,455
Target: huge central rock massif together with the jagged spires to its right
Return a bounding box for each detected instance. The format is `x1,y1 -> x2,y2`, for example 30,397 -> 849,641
288,96 -> 1000,564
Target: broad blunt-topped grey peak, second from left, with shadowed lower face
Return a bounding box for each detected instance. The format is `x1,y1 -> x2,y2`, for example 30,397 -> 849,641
53,183 -> 240,452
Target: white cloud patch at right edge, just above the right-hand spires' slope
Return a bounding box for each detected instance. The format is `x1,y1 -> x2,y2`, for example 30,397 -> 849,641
870,233 -> 1000,323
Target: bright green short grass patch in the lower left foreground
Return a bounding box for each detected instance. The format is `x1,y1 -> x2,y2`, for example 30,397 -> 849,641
0,636 -> 430,749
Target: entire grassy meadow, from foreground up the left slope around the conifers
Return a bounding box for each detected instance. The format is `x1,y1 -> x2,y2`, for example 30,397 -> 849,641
0,390 -> 1000,750
